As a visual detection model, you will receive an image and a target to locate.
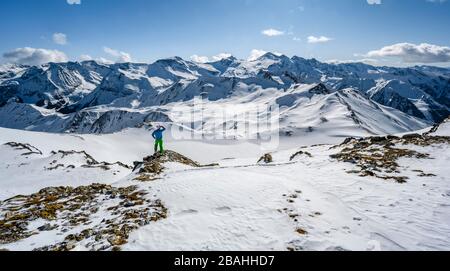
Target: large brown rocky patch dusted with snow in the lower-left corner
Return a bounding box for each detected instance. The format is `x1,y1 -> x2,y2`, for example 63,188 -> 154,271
0,184 -> 167,251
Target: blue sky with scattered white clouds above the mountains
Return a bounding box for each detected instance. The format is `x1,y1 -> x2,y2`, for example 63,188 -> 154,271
0,0 -> 450,66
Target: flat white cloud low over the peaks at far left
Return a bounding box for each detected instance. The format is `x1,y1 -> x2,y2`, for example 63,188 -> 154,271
3,47 -> 68,65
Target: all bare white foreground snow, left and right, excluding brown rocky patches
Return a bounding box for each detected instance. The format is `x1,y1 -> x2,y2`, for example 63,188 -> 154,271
0,125 -> 450,250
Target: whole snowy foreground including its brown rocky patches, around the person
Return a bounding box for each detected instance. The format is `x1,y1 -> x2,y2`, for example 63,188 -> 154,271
0,119 -> 450,253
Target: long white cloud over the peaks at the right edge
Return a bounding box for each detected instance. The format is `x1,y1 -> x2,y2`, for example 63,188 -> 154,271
367,42 -> 450,63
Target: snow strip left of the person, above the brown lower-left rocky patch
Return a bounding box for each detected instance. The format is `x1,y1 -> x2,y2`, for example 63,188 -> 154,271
0,142 -> 130,199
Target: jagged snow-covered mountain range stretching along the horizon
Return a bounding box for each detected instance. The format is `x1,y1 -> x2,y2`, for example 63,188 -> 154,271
0,53 -> 450,136
